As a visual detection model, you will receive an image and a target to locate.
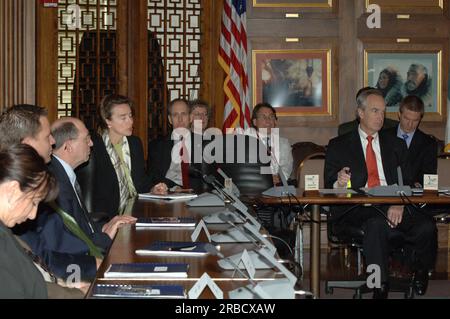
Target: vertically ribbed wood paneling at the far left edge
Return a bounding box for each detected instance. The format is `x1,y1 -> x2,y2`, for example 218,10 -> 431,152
0,0 -> 36,111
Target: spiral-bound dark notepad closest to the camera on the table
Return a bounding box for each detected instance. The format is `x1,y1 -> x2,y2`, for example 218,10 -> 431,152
92,284 -> 186,299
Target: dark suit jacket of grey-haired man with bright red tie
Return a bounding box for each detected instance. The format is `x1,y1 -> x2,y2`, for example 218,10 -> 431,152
324,130 -> 410,190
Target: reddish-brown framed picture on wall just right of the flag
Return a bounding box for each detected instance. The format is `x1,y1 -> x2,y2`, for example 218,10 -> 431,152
252,49 -> 332,116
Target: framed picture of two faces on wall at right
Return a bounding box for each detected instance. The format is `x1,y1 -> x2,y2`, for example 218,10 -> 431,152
364,50 -> 443,120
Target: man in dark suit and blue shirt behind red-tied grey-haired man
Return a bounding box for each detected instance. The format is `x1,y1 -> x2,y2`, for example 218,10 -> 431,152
386,95 -> 437,187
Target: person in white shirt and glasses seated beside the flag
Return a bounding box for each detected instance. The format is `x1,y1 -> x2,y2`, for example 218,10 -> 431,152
252,103 -> 294,184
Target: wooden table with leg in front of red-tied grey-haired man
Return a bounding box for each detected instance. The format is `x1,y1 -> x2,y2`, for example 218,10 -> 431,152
258,189 -> 450,298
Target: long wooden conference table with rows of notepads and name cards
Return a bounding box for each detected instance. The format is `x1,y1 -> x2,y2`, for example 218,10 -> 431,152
88,199 -> 283,298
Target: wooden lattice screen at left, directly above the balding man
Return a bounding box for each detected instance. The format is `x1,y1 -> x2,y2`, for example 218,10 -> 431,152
58,0 -> 117,129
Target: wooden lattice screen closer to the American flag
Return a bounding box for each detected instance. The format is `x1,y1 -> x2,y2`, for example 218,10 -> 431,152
148,0 -> 201,137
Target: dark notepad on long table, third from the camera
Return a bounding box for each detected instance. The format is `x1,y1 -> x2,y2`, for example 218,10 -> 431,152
136,241 -> 208,256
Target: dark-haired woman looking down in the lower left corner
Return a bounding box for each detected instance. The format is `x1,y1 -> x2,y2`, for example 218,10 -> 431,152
0,144 -> 58,299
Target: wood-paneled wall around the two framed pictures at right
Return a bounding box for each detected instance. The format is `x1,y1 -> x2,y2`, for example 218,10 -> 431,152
243,0 -> 450,144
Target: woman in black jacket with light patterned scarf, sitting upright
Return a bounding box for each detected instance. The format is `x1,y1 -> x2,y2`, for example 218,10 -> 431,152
91,95 -> 167,218
